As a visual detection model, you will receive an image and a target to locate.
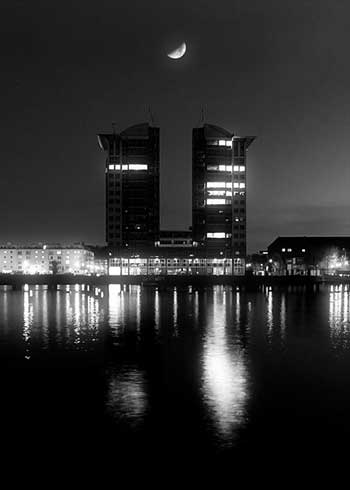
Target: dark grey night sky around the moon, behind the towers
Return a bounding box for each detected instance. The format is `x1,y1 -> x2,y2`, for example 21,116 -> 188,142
0,0 -> 350,252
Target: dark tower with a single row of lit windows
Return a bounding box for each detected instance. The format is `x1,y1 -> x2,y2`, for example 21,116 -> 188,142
98,123 -> 159,253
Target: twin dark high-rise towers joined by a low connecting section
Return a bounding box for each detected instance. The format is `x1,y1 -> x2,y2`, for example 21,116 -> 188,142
98,123 -> 254,274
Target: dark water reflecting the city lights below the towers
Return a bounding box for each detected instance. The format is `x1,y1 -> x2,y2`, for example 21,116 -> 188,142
0,285 -> 350,474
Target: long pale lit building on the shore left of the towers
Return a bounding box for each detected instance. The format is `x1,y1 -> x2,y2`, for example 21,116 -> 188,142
0,244 -> 94,274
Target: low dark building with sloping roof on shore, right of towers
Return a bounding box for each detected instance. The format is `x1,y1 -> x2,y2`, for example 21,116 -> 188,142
268,236 -> 350,275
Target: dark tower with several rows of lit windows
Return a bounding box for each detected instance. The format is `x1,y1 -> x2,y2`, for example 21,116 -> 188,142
192,124 -> 255,274
